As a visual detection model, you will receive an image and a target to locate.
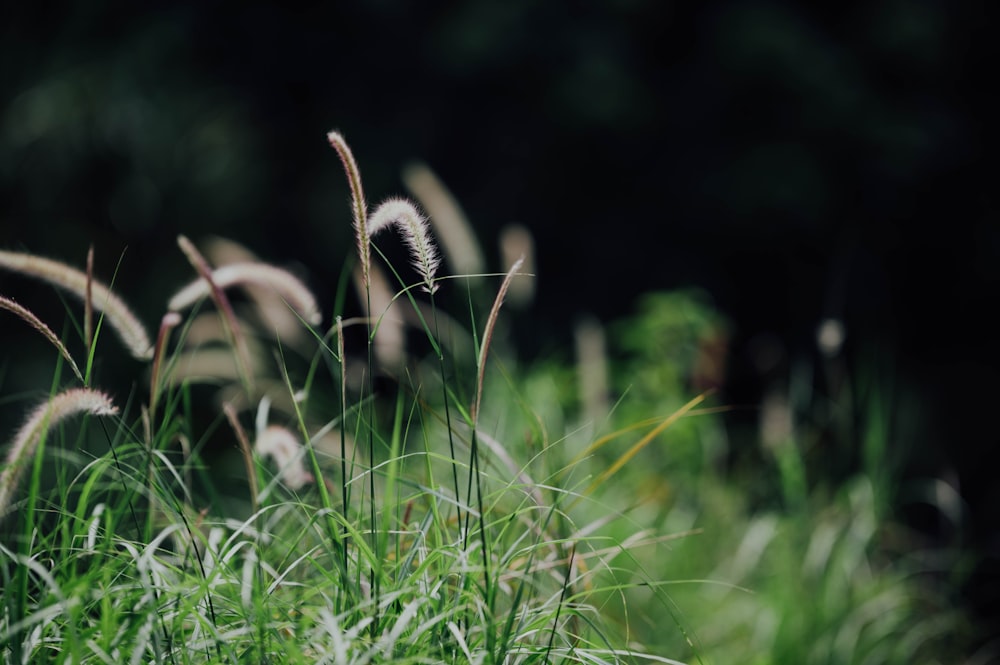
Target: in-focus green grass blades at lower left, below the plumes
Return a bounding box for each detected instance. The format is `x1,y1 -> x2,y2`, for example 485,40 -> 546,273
0,292 -> 688,663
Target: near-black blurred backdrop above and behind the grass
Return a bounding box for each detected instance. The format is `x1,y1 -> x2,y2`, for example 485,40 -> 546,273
0,0 -> 1000,644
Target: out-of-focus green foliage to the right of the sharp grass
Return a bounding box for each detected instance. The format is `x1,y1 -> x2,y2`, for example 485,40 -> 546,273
525,291 -> 984,665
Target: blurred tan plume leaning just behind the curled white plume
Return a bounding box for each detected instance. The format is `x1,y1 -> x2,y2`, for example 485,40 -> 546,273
403,163 -> 486,275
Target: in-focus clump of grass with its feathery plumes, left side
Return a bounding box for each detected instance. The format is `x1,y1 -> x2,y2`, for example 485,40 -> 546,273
0,133 -> 692,663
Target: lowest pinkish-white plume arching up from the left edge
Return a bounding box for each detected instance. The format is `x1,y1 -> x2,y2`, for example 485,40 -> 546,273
0,388 -> 118,519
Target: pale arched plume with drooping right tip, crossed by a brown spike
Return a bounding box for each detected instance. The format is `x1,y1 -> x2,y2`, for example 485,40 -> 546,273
167,263 -> 323,326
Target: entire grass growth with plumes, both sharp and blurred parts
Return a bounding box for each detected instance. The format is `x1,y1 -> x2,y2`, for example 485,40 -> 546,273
0,133 -> 991,664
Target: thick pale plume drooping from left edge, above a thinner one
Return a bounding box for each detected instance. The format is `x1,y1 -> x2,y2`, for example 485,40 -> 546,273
0,250 -> 153,360
